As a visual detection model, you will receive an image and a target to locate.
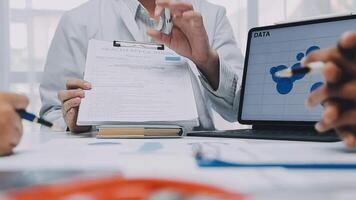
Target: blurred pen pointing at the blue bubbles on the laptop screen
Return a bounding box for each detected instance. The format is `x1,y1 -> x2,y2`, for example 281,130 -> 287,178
276,61 -> 325,78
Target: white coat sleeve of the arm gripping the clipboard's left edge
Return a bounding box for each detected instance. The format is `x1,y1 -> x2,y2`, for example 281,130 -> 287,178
40,14 -> 87,129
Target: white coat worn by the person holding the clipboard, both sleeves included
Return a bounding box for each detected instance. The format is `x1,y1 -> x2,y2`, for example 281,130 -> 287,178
40,0 -> 243,129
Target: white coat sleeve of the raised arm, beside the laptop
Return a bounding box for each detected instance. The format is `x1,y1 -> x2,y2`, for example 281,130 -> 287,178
200,8 -> 243,122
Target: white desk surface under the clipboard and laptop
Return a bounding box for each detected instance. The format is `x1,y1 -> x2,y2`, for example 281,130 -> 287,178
0,131 -> 356,199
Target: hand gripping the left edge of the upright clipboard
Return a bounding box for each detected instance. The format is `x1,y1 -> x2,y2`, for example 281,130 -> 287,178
58,79 -> 91,133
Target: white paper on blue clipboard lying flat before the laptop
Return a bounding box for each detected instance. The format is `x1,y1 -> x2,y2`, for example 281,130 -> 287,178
196,143 -> 356,170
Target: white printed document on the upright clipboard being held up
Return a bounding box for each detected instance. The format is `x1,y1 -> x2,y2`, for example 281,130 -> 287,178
78,40 -> 199,127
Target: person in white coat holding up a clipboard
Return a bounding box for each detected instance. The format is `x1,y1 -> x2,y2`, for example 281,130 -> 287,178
40,0 -> 243,133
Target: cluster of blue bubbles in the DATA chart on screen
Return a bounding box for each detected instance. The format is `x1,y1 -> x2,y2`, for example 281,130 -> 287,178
270,46 -> 323,95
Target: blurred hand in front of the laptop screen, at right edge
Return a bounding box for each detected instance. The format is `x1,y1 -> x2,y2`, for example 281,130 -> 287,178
302,32 -> 356,148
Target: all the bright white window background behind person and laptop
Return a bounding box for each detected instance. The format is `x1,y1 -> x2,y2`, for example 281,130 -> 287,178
0,0 -> 356,129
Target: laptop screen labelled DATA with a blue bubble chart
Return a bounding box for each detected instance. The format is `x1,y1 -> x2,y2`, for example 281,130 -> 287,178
239,16 -> 356,123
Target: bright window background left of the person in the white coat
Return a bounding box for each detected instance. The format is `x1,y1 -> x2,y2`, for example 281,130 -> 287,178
0,0 -> 87,133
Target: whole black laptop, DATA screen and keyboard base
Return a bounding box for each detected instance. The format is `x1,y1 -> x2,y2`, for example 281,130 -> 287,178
188,15 -> 356,142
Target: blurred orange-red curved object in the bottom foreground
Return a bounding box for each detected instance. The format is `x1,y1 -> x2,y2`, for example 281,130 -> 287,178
5,177 -> 244,200
